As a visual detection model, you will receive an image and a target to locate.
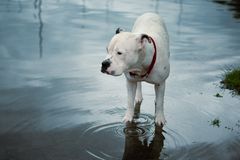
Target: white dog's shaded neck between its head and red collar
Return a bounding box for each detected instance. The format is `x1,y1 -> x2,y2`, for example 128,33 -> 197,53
128,42 -> 154,76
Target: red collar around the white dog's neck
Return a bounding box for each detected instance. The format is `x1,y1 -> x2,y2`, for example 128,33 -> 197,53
129,36 -> 157,78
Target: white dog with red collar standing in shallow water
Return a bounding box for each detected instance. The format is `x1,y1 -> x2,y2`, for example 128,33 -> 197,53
101,13 -> 170,126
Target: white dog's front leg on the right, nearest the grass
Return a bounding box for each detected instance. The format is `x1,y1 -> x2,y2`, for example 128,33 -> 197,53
154,82 -> 166,126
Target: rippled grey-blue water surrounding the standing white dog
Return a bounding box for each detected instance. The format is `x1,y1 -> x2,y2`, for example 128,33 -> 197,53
0,0 -> 240,160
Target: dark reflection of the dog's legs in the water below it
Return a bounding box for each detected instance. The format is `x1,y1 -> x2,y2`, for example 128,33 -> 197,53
123,117 -> 164,160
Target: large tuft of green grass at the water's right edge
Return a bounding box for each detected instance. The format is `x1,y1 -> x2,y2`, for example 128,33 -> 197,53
221,67 -> 240,95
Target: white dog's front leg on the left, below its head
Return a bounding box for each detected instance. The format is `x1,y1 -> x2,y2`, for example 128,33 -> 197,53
123,79 -> 137,123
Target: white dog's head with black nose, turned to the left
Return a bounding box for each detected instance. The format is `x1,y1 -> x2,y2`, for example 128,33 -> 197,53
101,28 -> 149,76
